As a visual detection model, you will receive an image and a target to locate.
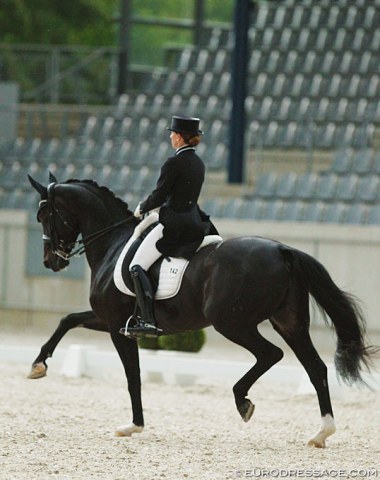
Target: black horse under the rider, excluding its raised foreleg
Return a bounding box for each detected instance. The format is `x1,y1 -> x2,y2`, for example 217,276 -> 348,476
29,177 -> 373,447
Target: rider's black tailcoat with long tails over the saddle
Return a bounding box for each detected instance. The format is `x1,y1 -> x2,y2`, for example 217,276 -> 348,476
140,146 -> 215,258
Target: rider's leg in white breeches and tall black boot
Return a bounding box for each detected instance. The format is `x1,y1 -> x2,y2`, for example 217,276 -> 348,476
128,224 -> 163,334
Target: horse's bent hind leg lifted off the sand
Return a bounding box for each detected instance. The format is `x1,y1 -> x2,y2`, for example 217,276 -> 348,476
218,326 -> 284,422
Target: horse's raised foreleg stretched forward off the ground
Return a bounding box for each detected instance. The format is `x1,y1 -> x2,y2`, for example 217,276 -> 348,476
28,310 -> 108,379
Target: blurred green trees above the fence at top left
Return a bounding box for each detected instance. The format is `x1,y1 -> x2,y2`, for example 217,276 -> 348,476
0,0 -> 233,47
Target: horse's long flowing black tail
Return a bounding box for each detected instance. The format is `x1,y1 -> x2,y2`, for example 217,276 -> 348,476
285,249 -> 379,385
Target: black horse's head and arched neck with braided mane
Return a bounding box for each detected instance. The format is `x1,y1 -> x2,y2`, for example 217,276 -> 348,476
28,174 -> 138,272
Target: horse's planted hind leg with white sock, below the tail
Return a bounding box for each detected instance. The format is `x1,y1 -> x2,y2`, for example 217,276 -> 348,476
270,289 -> 335,448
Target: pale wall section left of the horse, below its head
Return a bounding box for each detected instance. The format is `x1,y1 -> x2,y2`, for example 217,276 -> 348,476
0,210 -> 90,327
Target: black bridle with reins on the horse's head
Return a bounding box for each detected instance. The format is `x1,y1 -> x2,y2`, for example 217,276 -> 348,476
37,183 -> 135,261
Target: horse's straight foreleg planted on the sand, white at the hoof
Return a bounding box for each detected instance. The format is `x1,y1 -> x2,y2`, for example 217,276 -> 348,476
111,328 -> 144,437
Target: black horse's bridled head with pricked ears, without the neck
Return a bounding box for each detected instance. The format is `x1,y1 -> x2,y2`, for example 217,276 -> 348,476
28,173 -> 80,272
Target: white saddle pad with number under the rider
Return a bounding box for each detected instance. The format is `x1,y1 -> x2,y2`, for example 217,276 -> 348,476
113,212 -> 223,300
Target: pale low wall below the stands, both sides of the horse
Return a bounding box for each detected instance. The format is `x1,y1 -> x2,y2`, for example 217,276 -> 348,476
0,210 -> 380,333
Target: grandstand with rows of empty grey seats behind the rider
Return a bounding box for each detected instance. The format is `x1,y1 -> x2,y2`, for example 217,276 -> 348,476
0,0 -> 380,225
